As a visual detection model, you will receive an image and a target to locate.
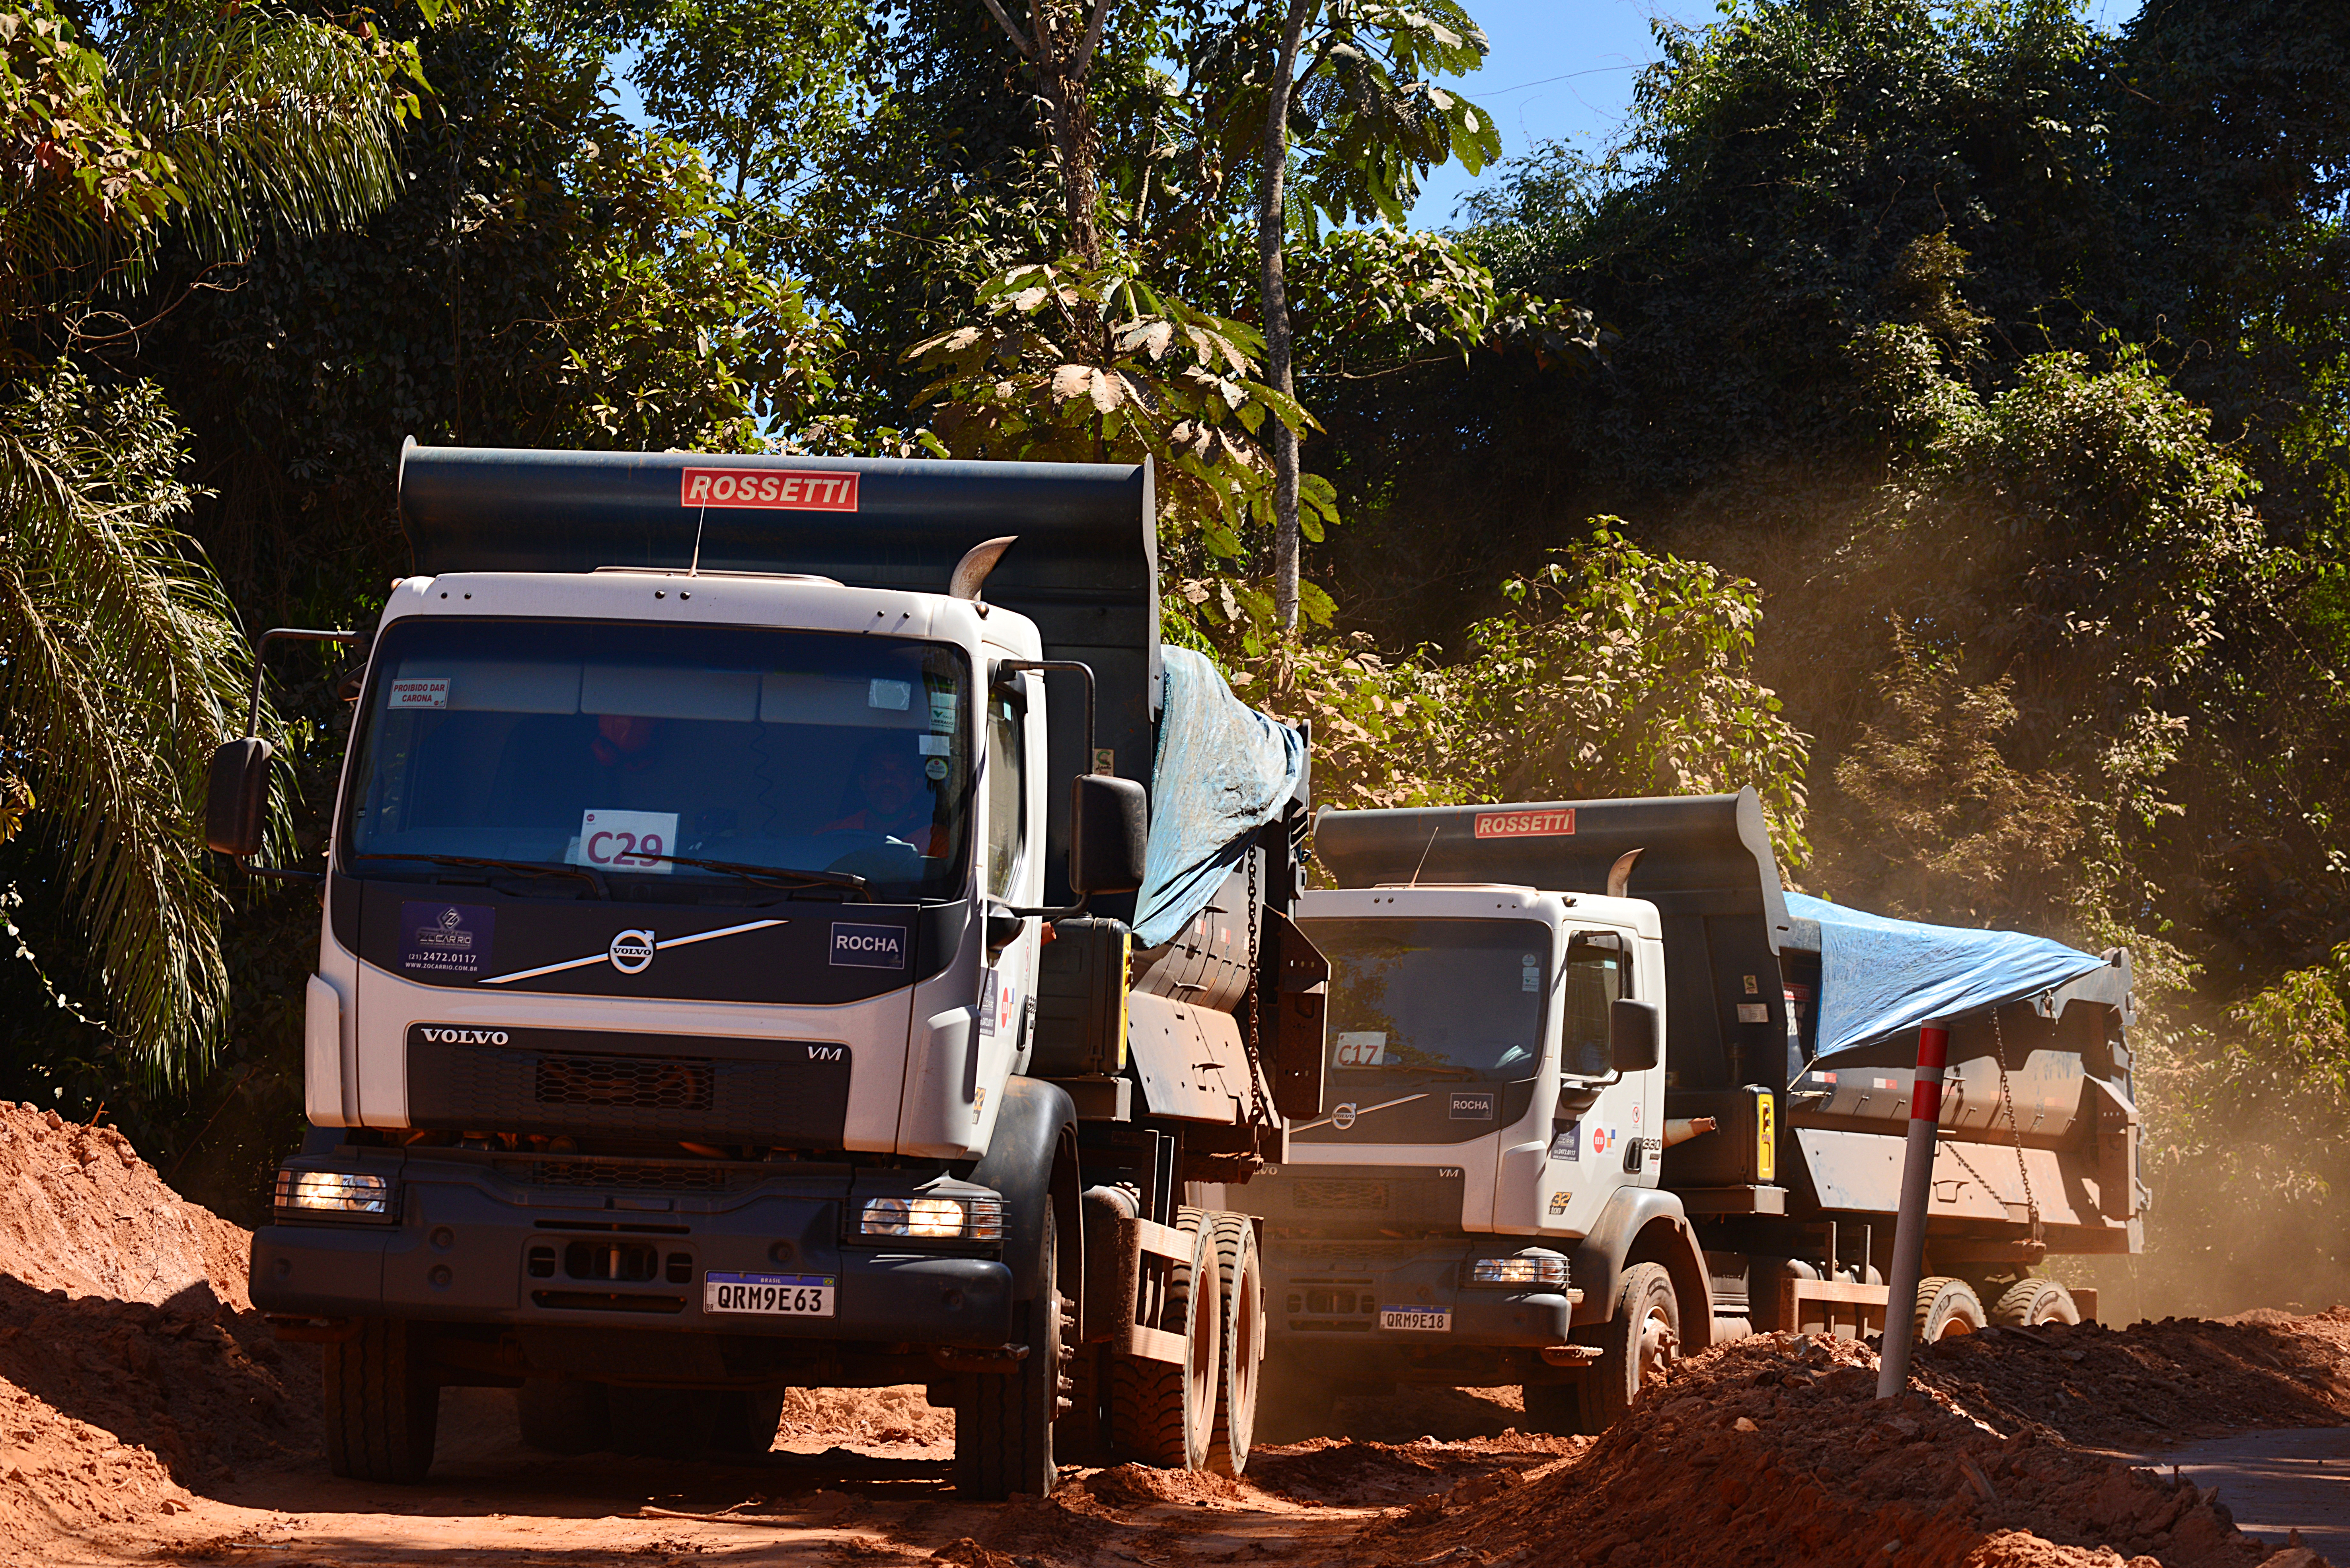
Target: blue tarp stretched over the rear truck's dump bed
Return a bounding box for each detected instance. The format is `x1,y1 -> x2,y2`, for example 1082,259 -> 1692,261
1786,893 -> 2106,1056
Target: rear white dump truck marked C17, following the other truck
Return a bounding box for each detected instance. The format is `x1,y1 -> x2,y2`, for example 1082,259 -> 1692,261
1234,790 -> 2143,1432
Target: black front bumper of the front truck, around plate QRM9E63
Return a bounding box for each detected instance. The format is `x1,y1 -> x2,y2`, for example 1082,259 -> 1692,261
251,1157 -> 1013,1347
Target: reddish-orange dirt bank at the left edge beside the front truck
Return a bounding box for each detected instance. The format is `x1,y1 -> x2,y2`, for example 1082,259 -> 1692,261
0,1105 -> 317,1540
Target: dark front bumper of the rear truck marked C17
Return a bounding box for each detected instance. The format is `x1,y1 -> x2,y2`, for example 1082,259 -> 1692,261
1264,1241 -> 1579,1350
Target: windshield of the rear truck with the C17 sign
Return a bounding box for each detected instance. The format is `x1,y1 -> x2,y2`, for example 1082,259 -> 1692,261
1304,919 -> 1551,1081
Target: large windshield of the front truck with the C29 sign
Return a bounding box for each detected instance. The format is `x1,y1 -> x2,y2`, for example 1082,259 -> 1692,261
341,616 -> 970,903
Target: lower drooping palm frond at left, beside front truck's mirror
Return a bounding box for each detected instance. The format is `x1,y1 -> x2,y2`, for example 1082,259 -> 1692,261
0,372 -> 262,1081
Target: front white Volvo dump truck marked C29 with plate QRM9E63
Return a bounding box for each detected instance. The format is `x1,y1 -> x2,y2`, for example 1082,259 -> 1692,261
207,444 -> 1323,1498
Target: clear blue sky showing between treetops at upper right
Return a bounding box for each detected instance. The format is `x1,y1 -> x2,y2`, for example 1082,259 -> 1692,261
1413,0 -> 2138,228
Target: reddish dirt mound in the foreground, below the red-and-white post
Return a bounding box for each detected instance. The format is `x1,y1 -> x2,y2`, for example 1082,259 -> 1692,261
1361,1335 -> 2293,1568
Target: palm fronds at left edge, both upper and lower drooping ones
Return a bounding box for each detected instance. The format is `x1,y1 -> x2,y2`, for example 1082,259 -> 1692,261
0,0 -> 416,1081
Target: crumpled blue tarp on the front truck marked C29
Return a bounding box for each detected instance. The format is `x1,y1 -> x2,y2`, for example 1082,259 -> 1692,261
1135,649 -> 1307,947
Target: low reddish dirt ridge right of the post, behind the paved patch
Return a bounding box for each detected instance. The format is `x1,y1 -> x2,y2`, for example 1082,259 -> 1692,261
1915,1307 -> 2350,1448
